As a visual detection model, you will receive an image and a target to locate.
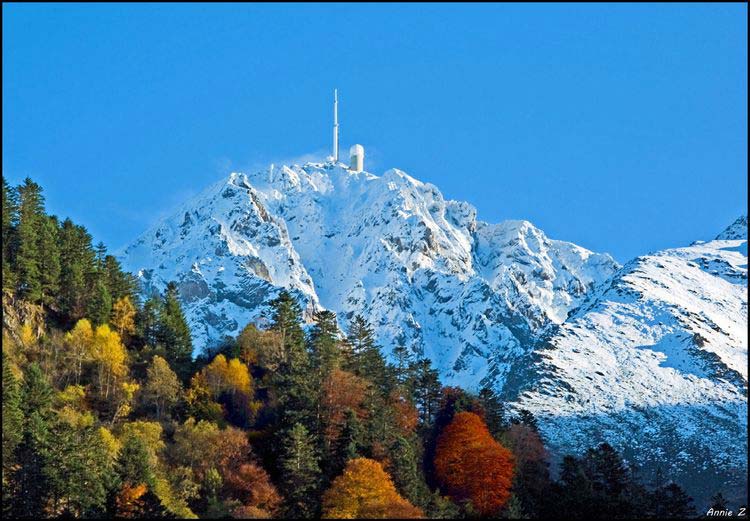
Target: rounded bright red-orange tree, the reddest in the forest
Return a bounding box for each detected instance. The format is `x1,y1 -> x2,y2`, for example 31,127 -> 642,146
435,412 -> 515,515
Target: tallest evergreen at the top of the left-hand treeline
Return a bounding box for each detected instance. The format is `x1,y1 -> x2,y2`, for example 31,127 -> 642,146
16,177 -> 45,302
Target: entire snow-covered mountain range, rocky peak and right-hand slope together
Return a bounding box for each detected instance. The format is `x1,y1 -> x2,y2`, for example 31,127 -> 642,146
120,163 -> 747,504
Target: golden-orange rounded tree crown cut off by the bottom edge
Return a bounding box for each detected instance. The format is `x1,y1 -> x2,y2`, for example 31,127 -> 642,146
323,458 -> 424,519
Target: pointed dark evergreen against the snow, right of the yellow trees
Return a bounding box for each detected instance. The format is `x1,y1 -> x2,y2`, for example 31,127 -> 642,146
157,282 -> 193,381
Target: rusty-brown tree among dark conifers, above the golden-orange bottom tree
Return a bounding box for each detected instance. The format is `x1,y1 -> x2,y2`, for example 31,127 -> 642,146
321,369 -> 369,443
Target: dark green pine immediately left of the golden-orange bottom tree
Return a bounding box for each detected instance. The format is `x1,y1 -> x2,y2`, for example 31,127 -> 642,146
281,423 -> 321,519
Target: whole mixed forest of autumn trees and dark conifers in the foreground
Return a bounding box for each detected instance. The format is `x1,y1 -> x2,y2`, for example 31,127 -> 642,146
2,178 -> 726,519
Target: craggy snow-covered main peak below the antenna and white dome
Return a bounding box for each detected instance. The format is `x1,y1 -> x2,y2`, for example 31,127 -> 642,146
120,163 -> 618,387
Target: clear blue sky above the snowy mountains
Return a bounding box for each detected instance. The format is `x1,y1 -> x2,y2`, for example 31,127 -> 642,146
2,4 -> 747,262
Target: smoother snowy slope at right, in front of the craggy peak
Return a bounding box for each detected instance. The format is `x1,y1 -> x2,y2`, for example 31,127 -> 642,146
506,217 -> 748,504
